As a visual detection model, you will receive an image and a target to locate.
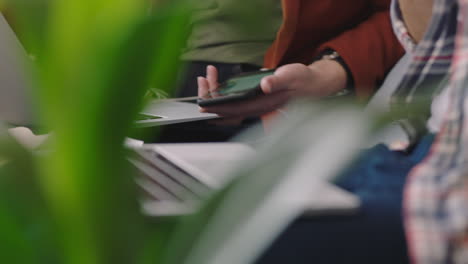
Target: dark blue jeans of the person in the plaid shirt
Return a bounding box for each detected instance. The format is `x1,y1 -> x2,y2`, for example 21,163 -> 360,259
257,135 -> 434,264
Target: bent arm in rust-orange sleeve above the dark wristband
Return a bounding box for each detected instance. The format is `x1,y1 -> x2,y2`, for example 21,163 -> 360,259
320,0 -> 404,97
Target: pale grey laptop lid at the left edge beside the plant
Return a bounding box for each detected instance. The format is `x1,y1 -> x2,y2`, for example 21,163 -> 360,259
0,13 -> 32,125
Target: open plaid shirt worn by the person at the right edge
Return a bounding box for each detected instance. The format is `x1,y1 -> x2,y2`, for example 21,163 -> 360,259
392,0 -> 468,264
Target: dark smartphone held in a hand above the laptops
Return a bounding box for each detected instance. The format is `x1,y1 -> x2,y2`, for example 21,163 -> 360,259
198,70 -> 275,107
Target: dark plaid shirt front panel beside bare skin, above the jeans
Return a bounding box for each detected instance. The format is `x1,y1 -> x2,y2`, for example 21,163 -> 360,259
391,0 -> 457,143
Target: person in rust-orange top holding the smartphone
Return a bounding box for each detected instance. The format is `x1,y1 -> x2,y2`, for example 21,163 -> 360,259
198,1 -> 401,117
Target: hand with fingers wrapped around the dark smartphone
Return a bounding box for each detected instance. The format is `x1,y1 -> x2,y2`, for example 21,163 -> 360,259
198,60 -> 346,117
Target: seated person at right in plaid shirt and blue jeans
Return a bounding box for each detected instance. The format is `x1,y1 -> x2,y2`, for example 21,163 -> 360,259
245,0 -> 458,263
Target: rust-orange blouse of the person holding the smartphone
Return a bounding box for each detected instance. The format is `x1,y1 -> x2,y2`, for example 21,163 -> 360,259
265,0 -> 403,98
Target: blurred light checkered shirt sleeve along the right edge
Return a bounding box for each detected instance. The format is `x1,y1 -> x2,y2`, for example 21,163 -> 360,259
404,0 -> 468,264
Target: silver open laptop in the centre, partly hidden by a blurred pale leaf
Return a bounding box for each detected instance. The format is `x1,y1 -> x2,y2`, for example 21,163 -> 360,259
129,122 -> 360,216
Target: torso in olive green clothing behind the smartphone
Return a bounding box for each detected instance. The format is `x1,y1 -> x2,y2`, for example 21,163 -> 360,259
176,0 -> 282,97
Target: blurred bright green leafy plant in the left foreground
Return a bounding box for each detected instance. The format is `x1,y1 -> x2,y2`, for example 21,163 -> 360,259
0,0 -> 189,264
